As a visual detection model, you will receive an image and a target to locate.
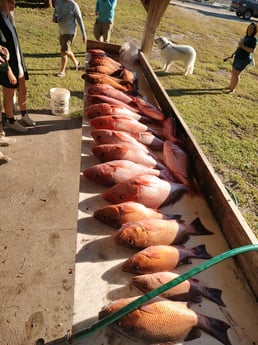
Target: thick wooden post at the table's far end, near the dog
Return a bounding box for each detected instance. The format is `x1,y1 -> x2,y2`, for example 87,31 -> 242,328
141,0 -> 170,58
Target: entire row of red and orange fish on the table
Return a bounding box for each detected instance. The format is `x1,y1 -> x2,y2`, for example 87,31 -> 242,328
82,49 -> 231,345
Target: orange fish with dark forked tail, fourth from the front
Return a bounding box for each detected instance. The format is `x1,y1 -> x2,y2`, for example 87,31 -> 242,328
114,218 -> 213,249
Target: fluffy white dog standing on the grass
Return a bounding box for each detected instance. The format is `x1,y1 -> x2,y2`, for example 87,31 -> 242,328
154,36 -> 196,75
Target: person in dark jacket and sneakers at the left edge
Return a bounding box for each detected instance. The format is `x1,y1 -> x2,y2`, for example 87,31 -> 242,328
0,0 -> 36,132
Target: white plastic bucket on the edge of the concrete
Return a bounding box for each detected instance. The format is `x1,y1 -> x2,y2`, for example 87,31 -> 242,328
49,87 -> 70,115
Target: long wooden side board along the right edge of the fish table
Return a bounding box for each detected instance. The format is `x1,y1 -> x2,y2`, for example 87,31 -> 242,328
139,52 -> 258,300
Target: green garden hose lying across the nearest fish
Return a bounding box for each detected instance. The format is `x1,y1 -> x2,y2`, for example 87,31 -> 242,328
72,244 -> 258,339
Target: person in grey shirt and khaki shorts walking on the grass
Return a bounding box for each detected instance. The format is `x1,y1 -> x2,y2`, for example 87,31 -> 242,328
53,0 -> 87,77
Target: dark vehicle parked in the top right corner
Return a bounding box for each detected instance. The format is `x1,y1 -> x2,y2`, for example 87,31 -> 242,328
230,0 -> 258,20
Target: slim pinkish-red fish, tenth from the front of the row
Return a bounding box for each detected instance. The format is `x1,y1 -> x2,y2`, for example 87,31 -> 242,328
89,115 -> 159,136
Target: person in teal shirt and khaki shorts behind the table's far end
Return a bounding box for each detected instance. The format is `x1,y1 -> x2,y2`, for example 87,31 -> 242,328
93,0 -> 117,42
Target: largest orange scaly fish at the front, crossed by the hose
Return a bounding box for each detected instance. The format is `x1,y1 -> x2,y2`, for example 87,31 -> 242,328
99,296 -> 231,345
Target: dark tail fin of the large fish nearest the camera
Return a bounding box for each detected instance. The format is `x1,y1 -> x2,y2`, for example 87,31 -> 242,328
198,314 -> 232,345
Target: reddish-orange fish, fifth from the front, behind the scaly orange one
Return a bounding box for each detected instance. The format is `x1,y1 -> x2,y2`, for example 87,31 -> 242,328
94,201 -> 180,228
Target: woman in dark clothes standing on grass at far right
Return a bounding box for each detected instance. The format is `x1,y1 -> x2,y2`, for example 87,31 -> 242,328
228,23 -> 257,94
